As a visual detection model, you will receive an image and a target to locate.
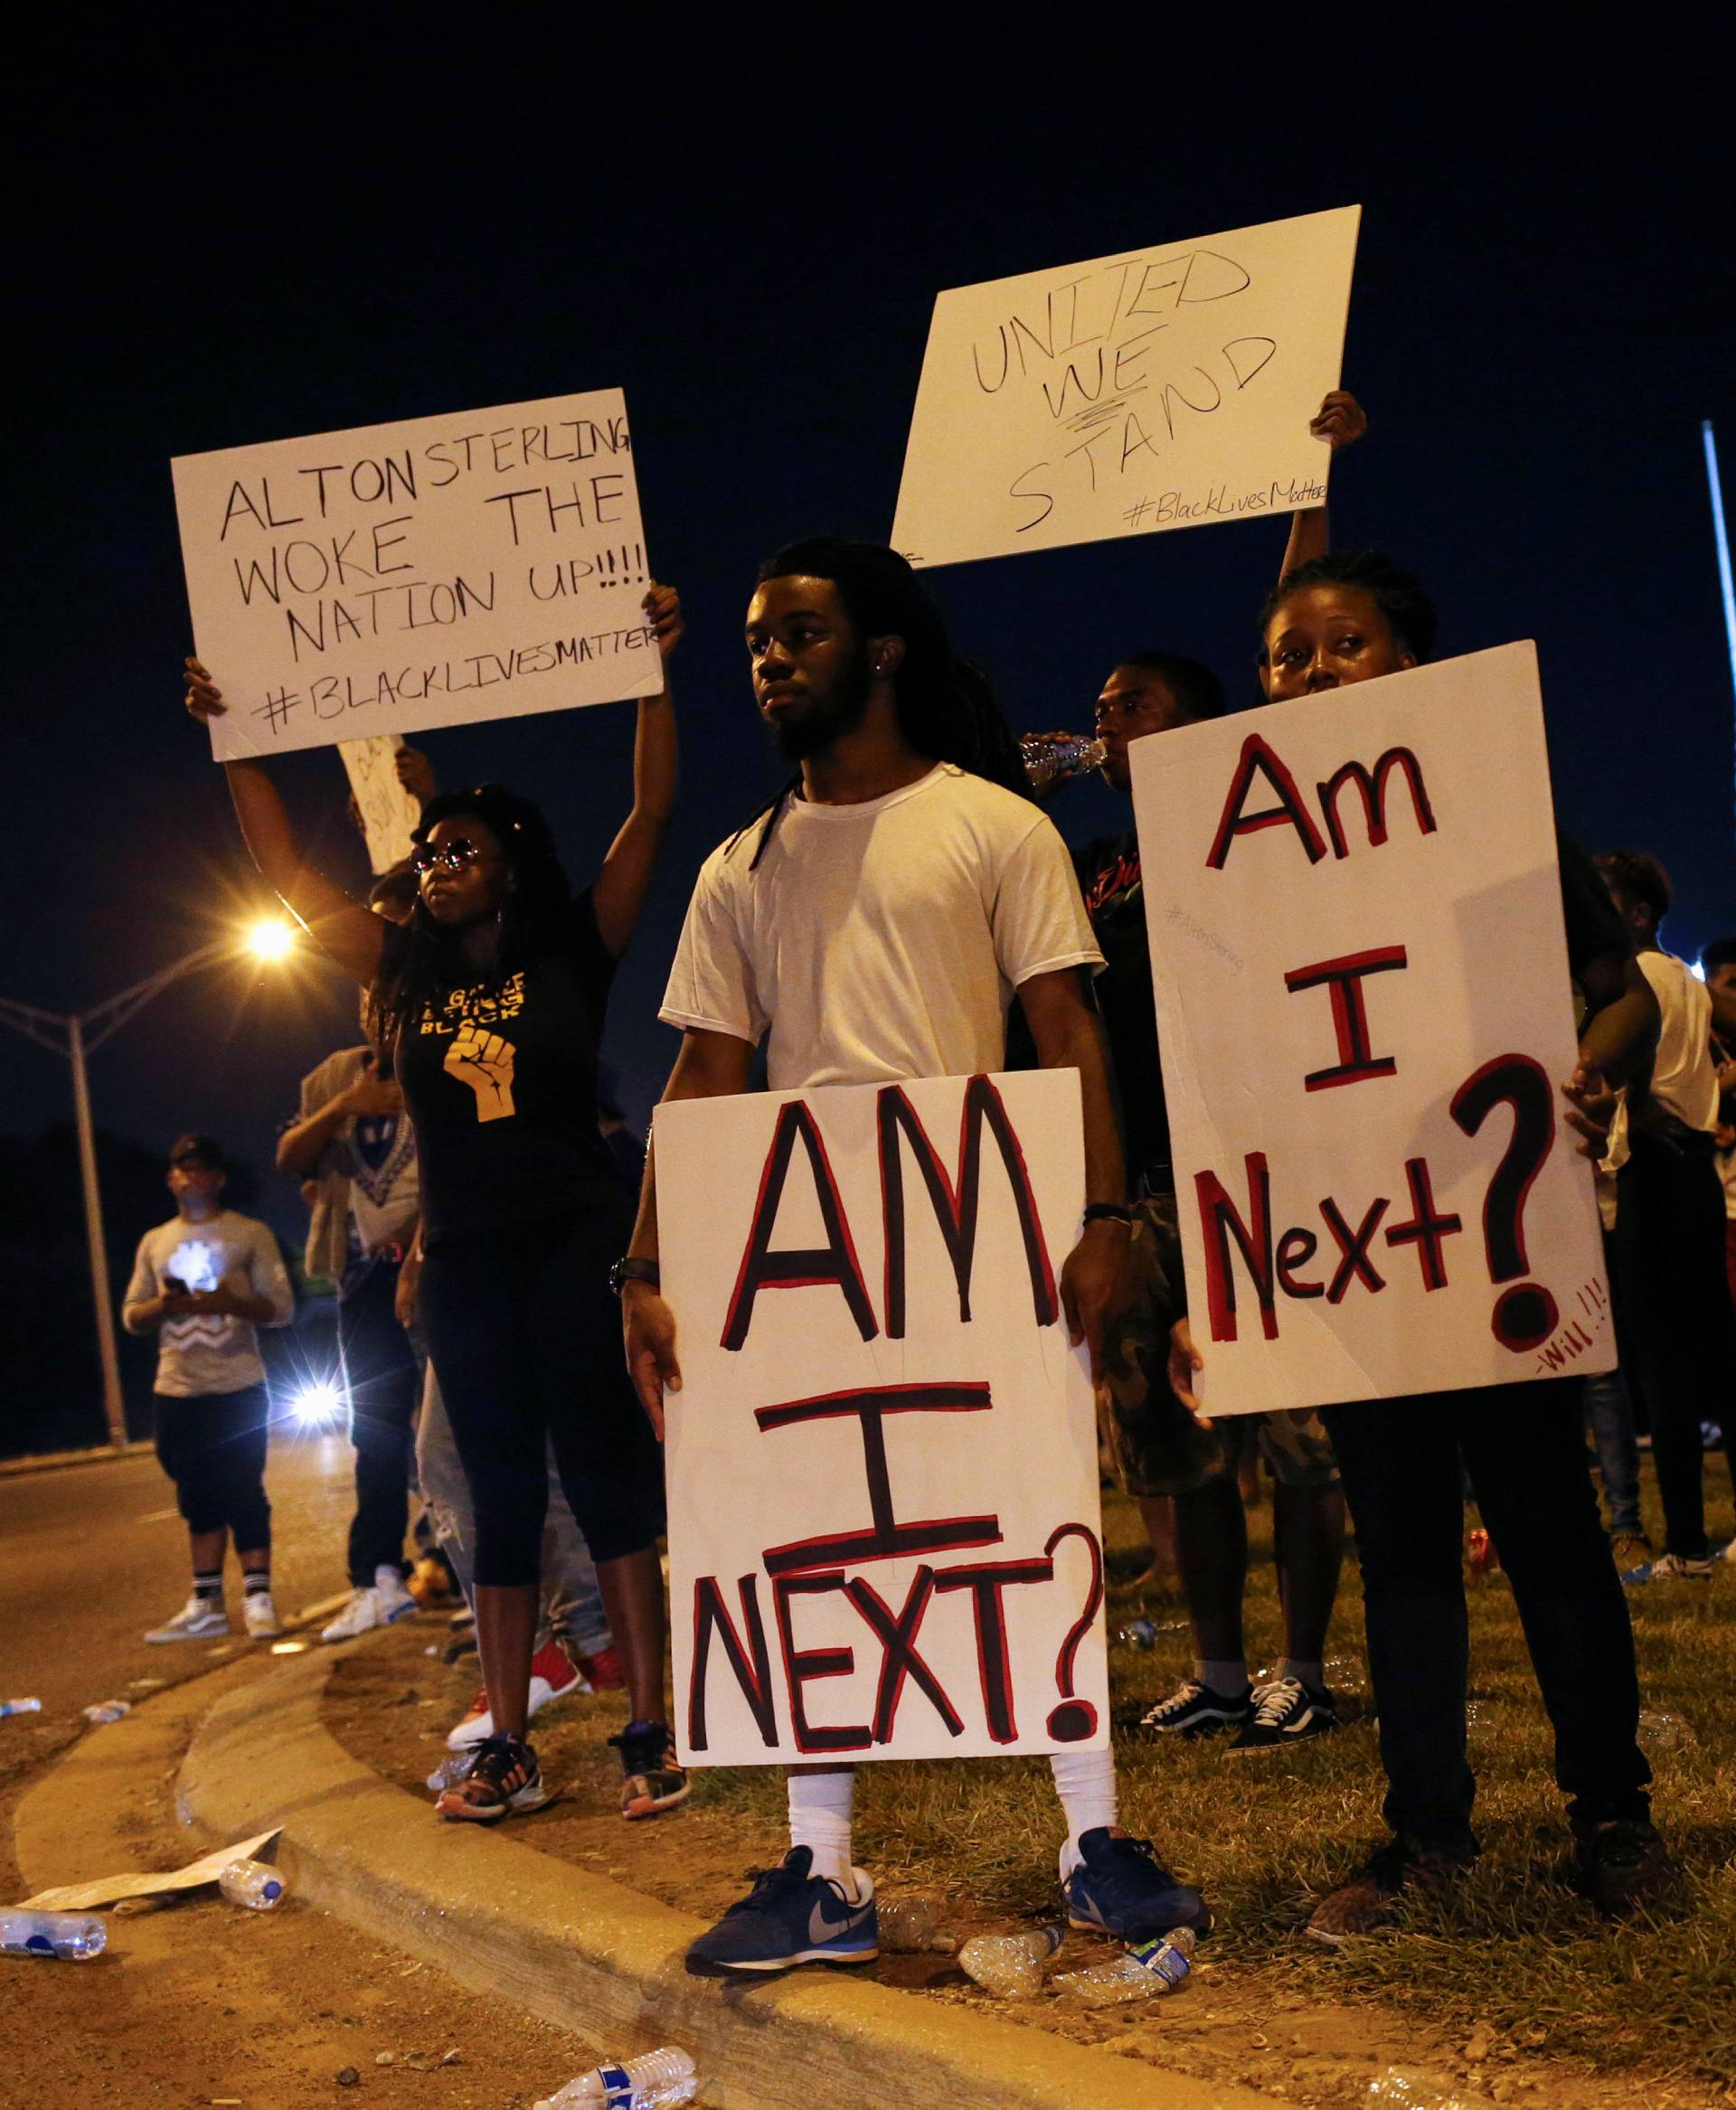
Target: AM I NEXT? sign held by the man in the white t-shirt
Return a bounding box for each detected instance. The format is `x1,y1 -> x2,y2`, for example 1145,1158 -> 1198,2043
656,1069 -> 1109,1766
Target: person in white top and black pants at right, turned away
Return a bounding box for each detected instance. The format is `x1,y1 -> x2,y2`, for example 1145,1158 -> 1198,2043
1597,851 -> 1736,1583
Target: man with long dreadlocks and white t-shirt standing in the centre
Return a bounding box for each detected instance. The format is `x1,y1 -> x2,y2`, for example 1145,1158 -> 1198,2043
616,536 -> 1211,1975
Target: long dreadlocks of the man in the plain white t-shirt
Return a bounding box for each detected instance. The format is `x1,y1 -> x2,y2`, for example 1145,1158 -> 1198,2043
734,534 -> 1032,871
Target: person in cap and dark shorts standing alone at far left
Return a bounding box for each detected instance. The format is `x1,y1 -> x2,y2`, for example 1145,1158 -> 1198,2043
120,1135 -> 296,1642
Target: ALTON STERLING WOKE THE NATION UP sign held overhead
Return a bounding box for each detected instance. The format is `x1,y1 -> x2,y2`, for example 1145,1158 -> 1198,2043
173,388 -> 663,762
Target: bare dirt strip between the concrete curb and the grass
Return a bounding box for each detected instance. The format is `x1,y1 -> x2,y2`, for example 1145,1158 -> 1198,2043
327,1625 -> 1730,2110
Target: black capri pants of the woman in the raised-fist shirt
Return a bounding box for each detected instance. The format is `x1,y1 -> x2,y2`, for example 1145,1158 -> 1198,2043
418,1209 -> 663,1587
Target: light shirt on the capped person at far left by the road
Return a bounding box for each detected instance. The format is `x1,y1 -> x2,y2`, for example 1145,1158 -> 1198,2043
120,1209 -> 296,1399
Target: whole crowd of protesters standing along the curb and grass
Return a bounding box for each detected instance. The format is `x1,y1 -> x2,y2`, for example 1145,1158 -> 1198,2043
125,394 -> 1736,1975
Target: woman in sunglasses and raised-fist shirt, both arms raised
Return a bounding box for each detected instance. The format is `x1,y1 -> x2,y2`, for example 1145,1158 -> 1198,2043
185,587 -> 688,1823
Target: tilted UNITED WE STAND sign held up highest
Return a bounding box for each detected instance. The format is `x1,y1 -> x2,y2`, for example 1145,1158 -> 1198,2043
892,204 -> 1361,563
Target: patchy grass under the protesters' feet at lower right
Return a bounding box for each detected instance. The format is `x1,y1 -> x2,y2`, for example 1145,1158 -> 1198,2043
694,1458 -> 1736,2086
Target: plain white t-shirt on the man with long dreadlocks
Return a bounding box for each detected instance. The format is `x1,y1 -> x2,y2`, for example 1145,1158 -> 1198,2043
658,762 -> 1103,1091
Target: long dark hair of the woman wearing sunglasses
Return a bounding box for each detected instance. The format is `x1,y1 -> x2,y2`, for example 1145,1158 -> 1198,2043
369,785 -> 571,1047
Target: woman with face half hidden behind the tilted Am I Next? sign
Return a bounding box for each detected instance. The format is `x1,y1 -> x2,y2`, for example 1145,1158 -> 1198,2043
1171,551 -> 1673,1944
